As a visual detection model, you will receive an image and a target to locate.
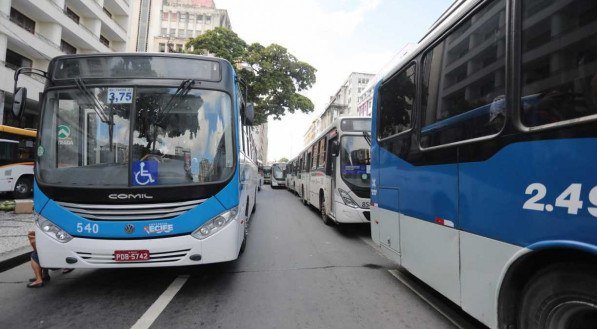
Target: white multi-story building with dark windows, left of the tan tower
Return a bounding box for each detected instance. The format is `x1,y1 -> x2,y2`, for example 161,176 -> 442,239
0,0 -> 130,128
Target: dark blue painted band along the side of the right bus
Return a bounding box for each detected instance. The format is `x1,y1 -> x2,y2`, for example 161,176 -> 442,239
372,138 -> 597,248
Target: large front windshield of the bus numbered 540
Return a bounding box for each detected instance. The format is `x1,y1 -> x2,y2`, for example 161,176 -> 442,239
37,85 -> 234,187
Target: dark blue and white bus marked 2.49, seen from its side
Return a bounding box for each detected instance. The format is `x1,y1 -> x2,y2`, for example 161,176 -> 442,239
371,0 -> 597,329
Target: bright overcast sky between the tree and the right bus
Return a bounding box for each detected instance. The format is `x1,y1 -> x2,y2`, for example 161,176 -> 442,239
215,0 -> 453,161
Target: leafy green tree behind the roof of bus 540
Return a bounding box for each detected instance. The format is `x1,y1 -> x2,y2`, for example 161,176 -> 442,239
186,27 -> 317,124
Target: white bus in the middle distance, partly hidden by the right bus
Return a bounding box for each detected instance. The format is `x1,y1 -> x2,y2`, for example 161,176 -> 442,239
295,117 -> 371,225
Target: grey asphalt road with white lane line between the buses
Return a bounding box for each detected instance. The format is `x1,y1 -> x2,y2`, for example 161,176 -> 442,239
0,187 -> 453,329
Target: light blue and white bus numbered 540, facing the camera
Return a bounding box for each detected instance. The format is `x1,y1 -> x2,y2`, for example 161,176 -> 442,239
11,53 -> 258,268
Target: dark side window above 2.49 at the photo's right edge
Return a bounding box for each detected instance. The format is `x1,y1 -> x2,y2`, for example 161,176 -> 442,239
520,0 -> 597,127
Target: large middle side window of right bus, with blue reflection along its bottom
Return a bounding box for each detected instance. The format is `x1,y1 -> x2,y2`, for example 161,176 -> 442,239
420,0 -> 506,147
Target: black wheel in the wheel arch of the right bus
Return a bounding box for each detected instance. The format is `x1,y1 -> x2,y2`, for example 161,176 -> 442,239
518,263 -> 597,329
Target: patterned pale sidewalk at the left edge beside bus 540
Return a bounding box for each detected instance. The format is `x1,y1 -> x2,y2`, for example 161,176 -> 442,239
0,211 -> 34,272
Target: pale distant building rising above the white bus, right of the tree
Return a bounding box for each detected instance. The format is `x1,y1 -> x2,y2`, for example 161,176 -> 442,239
303,72 -> 374,145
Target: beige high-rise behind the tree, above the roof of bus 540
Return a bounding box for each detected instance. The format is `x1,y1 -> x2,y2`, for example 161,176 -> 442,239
128,0 -> 231,52
